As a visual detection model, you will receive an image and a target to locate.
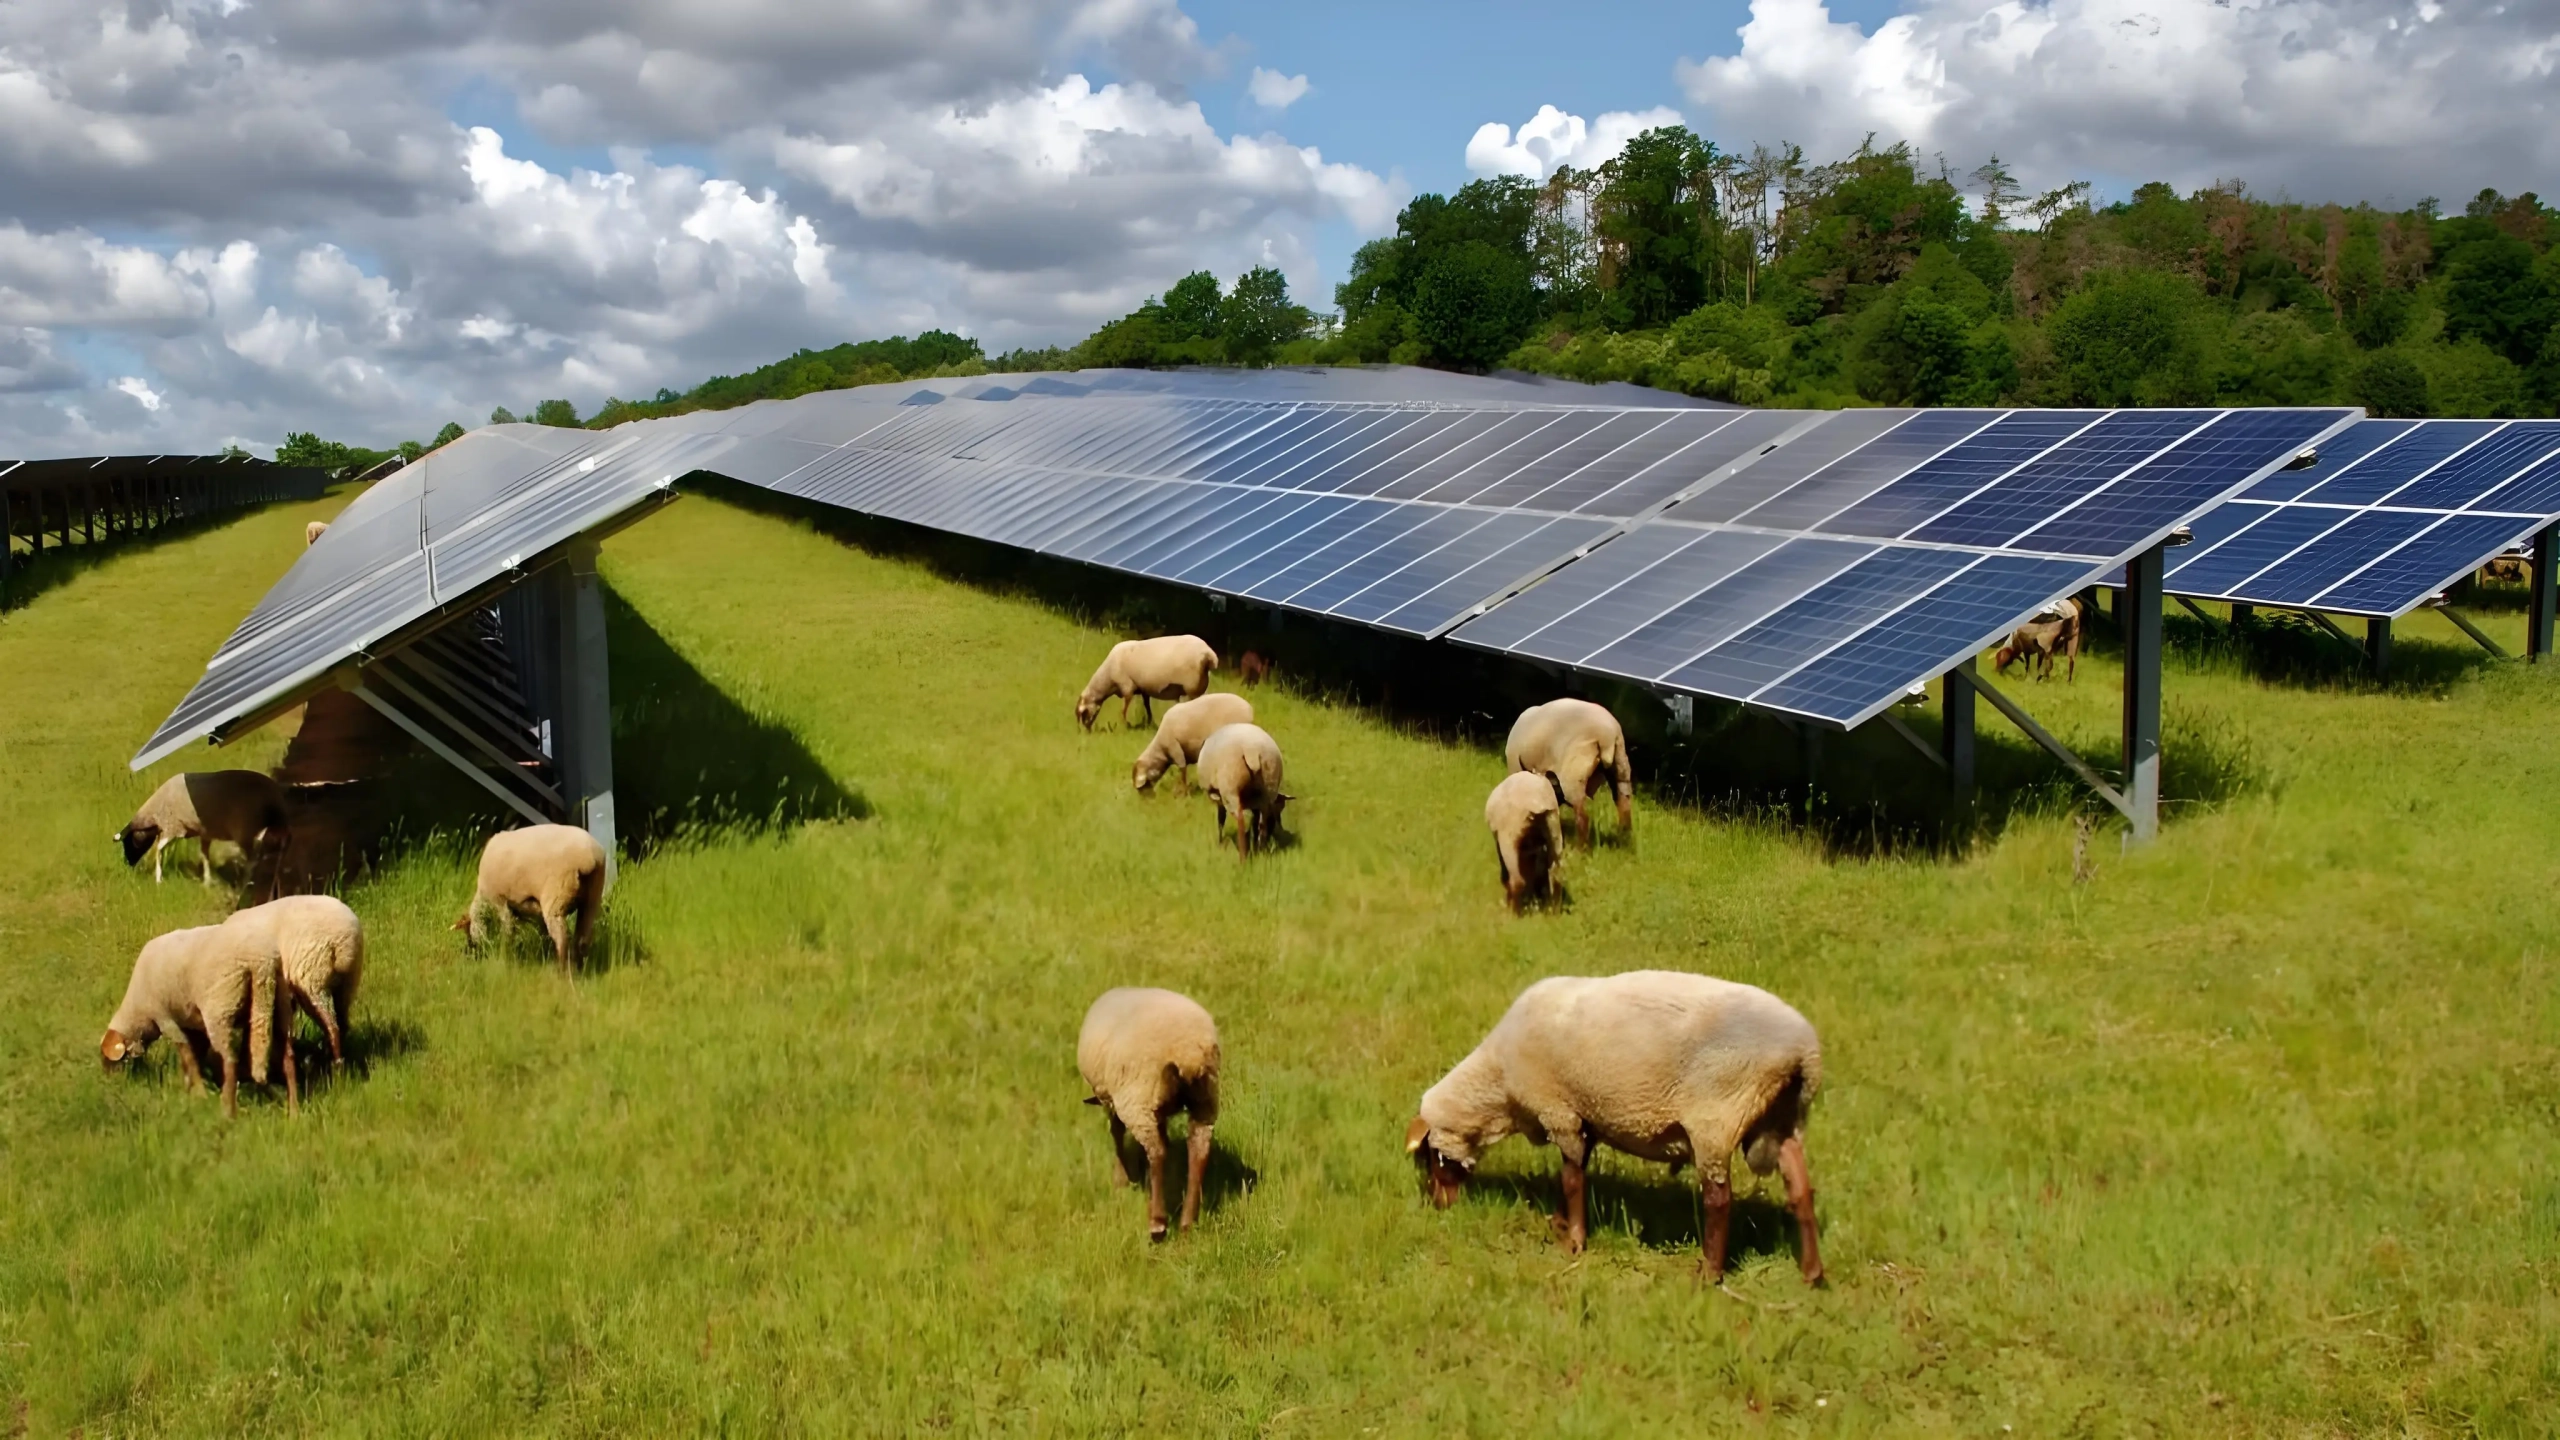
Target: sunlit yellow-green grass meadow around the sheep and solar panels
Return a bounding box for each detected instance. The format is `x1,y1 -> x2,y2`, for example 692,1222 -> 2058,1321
0,486 -> 2560,1435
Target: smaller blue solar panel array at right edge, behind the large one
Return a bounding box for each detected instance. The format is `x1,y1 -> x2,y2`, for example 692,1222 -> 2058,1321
2163,420 -> 2560,618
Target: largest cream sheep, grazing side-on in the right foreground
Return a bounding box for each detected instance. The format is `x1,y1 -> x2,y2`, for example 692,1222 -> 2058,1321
1405,971 -> 1823,1284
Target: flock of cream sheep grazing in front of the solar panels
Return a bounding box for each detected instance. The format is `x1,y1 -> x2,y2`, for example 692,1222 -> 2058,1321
100,622 -> 1823,1284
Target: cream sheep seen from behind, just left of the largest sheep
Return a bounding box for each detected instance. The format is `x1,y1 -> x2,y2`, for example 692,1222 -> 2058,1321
1075,989 -> 1219,1240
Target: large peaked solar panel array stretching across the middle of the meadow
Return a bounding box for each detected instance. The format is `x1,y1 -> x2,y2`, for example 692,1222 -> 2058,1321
136,369 -> 2355,764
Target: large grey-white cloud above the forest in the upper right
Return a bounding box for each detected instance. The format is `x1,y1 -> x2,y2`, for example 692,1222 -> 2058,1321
1679,0 -> 2560,202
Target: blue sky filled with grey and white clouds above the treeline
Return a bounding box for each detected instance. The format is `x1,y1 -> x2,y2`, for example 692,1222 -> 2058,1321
0,0 -> 2560,456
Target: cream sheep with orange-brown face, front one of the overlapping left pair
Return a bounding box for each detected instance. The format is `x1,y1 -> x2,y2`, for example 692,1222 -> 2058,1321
97,922 -> 302,1117
